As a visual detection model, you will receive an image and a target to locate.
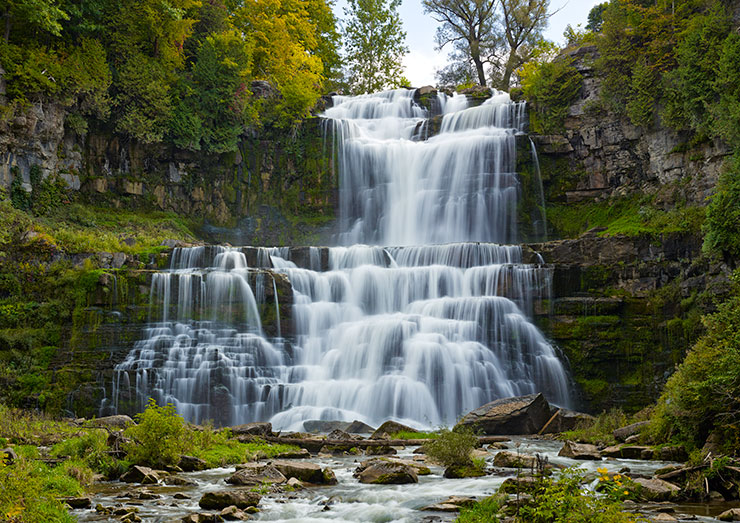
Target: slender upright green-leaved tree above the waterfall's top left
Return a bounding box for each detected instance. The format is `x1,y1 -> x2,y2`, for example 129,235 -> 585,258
343,0 -> 408,93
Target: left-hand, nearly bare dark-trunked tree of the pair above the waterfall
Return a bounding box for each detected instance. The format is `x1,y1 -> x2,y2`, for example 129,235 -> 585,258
423,0 -> 498,85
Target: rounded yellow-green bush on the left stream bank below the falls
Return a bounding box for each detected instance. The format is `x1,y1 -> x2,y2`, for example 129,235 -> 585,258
124,398 -> 189,467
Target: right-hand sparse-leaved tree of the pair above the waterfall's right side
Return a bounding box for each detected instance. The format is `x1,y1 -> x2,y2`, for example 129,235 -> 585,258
499,0 -> 550,89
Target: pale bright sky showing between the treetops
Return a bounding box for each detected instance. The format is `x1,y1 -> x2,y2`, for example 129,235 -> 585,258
334,0 -> 604,87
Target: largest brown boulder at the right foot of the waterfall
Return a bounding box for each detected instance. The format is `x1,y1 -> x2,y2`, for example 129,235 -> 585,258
457,394 -> 552,436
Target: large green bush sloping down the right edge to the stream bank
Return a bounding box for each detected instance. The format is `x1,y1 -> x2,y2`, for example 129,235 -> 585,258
651,272 -> 740,455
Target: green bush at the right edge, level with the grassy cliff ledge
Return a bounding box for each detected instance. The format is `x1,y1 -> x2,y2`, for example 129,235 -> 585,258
703,153 -> 740,259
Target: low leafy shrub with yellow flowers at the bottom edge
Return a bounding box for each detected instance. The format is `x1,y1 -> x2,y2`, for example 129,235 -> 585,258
516,468 -> 647,523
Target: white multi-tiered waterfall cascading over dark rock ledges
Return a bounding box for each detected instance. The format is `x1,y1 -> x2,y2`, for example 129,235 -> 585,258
106,89 -> 570,430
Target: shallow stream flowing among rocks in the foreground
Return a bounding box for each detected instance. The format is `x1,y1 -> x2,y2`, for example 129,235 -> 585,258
72,437 -> 737,523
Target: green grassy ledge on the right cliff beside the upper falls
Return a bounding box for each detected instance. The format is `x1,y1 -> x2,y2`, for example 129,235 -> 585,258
547,196 -> 705,238
